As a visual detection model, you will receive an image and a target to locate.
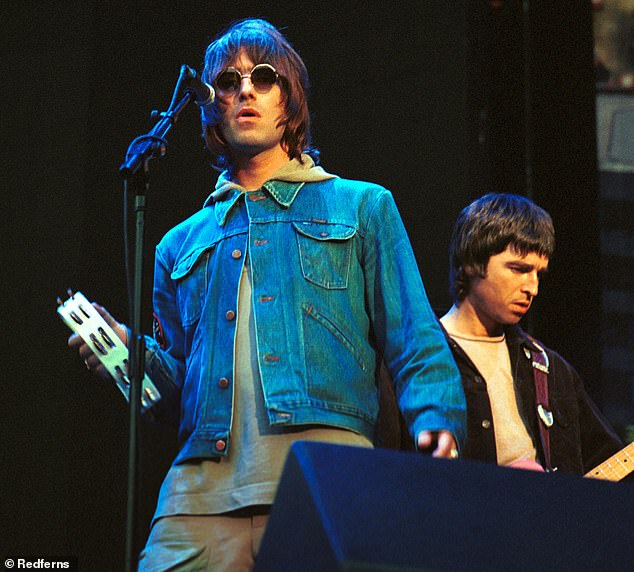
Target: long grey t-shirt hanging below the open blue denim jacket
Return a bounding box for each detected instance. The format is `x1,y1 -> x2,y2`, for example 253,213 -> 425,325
154,237 -> 372,519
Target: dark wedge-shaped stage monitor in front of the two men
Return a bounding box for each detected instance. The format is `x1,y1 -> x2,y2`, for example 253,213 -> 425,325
255,442 -> 634,572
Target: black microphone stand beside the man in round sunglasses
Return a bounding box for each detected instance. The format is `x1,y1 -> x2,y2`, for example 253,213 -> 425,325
119,66 -> 193,572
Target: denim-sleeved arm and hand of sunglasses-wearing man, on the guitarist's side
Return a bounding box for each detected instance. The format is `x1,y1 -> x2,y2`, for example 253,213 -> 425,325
364,191 -> 466,450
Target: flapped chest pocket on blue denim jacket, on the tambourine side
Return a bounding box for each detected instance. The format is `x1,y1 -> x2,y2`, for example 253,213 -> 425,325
170,245 -> 215,327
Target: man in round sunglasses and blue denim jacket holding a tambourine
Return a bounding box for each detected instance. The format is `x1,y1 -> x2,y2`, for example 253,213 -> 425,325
70,20 -> 465,570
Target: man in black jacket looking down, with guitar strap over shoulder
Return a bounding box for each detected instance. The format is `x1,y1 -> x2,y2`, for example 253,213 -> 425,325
441,194 -> 620,474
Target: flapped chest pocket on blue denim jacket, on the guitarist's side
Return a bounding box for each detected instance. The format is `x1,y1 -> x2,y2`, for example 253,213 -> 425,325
293,221 -> 357,290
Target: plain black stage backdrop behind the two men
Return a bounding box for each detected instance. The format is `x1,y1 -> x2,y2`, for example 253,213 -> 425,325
0,0 -> 624,571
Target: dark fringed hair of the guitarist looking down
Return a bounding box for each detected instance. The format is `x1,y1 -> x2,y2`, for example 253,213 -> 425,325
449,193 -> 555,303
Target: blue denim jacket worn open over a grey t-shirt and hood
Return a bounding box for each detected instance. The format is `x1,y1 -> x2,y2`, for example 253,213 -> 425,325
146,173 -> 466,463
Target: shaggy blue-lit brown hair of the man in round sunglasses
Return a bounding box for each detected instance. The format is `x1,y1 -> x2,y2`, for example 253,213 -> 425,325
202,18 -> 319,173
